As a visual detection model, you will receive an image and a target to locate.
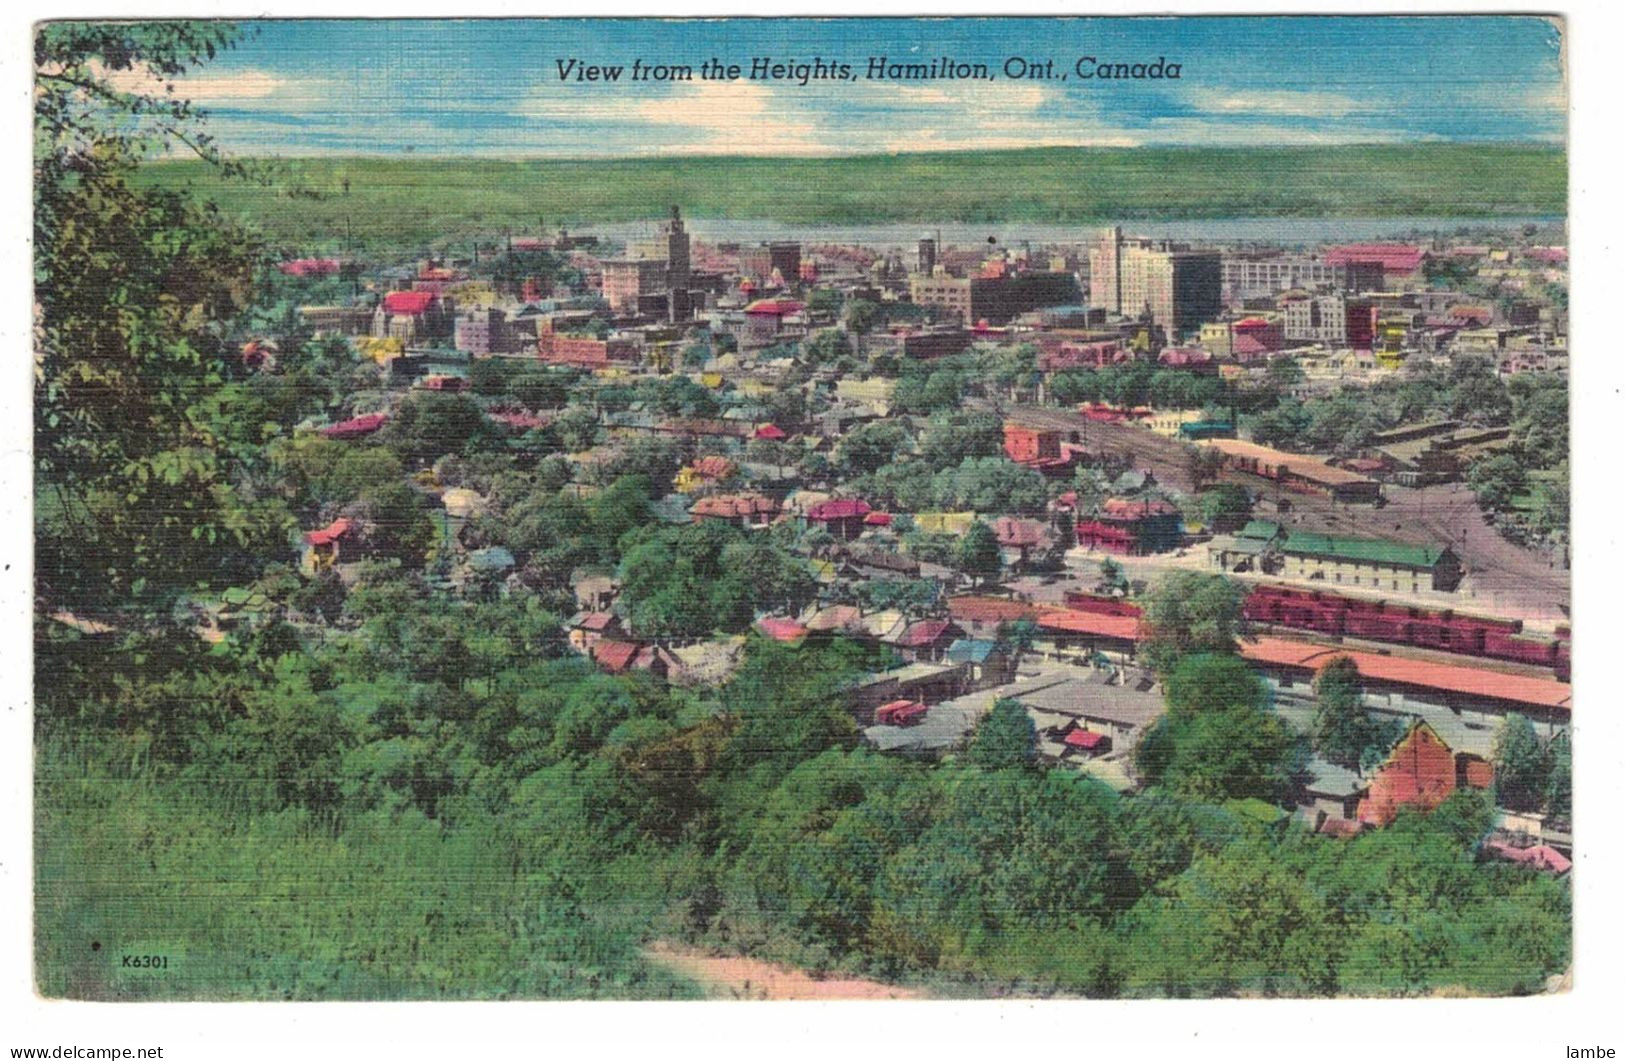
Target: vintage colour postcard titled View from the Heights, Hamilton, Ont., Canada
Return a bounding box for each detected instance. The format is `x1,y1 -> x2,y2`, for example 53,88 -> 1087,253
33,15 -> 1566,1000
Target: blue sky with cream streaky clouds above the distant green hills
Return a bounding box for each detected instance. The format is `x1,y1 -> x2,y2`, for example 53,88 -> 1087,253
133,16 -> 1567,158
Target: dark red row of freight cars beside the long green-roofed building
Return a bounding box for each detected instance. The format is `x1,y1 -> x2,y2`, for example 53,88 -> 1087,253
1242,585 -> 1570,681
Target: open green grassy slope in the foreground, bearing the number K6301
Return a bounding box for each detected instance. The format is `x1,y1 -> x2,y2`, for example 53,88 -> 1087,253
34,757 -> 699,1001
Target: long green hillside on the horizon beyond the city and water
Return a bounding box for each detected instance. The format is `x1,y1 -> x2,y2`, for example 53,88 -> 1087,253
136,145 -> 1568,249
